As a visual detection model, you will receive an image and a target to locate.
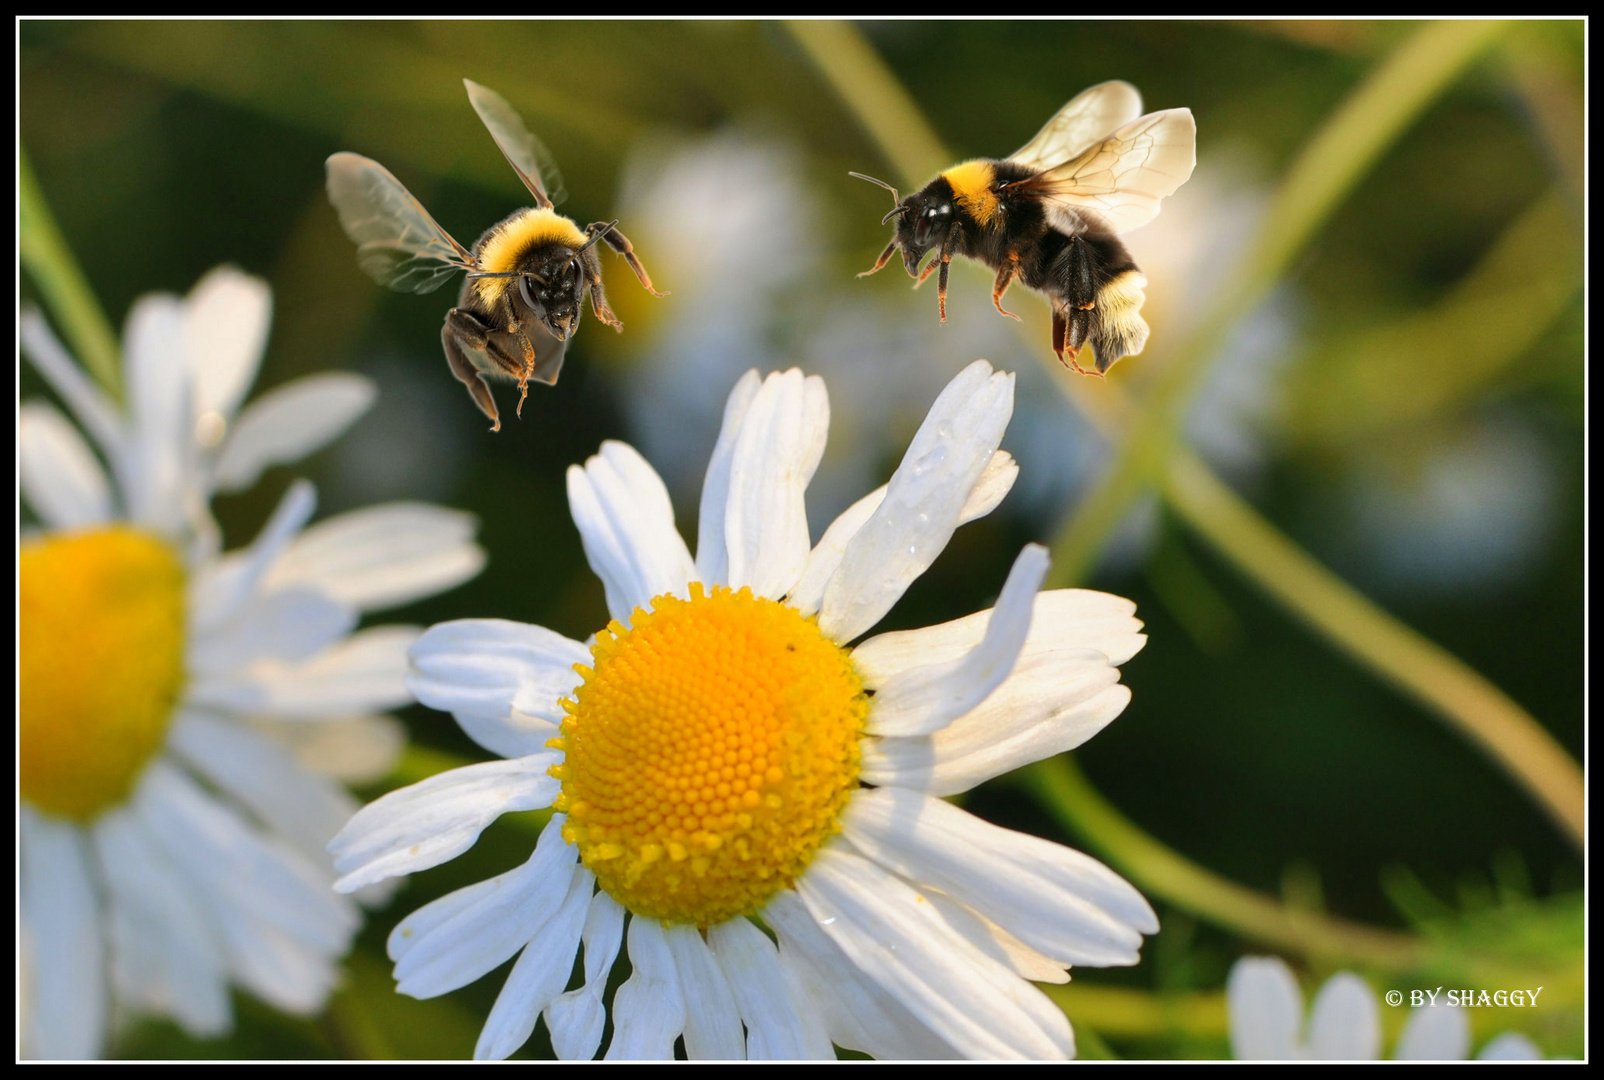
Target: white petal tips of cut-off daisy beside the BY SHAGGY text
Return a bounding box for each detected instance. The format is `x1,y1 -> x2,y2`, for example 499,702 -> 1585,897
1225,956 -> 1543,1061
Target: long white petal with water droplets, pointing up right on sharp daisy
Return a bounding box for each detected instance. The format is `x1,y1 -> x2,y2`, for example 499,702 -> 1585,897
818,359 -> 1014,642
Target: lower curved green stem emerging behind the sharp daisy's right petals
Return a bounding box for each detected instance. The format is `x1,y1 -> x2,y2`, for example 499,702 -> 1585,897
1019,754 -> 1424,972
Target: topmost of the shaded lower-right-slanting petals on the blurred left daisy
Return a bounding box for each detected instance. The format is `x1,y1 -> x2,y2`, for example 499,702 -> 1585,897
168,711 -> 359,868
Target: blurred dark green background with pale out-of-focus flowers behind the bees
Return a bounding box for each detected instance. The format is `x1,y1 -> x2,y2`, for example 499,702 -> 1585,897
19,21 -> 1585,1058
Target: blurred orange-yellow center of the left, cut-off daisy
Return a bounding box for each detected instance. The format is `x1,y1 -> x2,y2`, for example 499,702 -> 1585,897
18,526 -> 184,822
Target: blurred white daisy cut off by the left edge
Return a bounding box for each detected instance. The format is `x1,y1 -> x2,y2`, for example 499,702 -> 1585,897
18,270 -> 483,1058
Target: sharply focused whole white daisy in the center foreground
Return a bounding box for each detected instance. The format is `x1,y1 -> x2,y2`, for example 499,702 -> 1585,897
329,361 -> 1158,1059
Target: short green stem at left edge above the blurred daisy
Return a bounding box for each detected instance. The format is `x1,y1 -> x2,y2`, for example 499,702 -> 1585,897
18,142 -> 122,401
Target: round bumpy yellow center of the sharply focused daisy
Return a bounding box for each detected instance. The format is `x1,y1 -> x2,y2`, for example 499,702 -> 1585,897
552,584 -> 869,926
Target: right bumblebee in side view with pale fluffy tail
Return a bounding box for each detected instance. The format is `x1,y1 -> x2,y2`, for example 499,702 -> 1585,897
852,82 -> 1197,376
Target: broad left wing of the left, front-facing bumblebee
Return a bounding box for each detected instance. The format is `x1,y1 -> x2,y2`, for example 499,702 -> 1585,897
329,151 -> 475,292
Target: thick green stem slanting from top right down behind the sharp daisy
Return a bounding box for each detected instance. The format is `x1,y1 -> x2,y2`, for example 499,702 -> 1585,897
1047,21 -> 1505,587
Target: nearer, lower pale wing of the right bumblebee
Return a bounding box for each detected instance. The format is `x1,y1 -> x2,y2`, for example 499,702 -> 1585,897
1017,109 -> 1197,233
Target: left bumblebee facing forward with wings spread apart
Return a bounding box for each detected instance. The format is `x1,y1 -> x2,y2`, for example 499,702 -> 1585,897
329,79 -> 662,432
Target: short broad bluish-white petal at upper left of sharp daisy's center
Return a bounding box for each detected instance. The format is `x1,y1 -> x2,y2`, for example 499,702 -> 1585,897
407,619 -> 590,757
